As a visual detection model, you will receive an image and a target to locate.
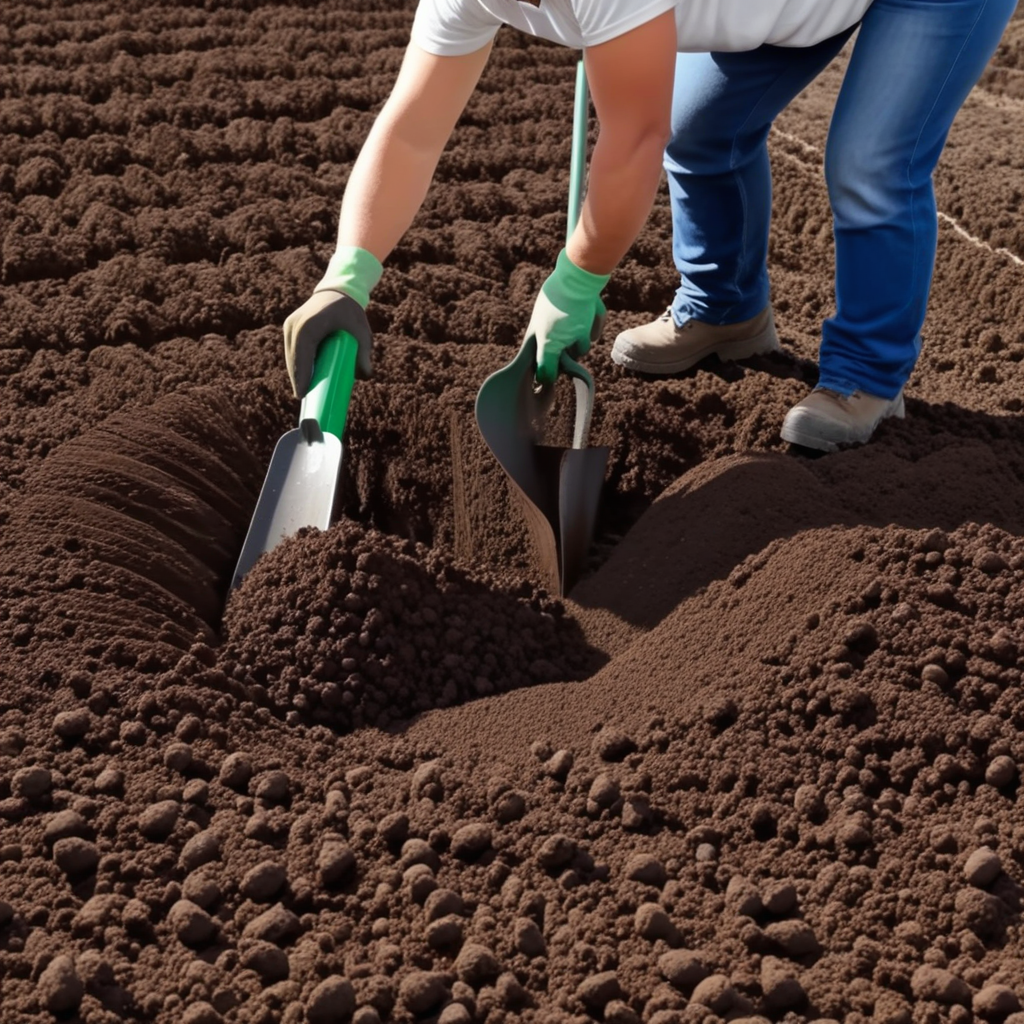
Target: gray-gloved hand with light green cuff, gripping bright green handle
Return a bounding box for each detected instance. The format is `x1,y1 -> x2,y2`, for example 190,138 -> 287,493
285,246 -> 383,398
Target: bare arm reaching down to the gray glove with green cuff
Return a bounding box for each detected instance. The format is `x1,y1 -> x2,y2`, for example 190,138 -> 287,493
338,43 -> 490,262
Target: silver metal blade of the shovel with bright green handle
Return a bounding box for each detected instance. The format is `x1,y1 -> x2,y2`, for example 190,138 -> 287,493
231,420 -> 342,590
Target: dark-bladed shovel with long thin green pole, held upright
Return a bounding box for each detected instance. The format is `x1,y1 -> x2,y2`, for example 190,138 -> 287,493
476,60 -> 608,597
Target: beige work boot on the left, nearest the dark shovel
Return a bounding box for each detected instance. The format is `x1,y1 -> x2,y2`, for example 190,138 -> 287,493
611,306 -> 779,374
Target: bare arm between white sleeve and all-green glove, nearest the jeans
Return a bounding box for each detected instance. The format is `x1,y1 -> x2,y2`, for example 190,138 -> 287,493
566,11 -> 676,273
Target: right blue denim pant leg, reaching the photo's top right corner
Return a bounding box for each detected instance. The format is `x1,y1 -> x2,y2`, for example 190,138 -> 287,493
818,0 -> 1016,398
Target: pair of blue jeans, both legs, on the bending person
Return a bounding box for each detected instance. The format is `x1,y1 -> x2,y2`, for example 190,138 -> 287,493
665,0 -> 1017,398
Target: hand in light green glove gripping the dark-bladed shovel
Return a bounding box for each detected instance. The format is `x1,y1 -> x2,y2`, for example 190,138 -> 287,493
526,249 -> 610,384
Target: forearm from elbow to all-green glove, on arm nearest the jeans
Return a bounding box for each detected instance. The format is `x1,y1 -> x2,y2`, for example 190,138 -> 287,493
566,131 -> 666,273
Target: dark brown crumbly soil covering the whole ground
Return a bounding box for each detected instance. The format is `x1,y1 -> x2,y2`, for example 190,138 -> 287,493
0,0 -> 1024,1024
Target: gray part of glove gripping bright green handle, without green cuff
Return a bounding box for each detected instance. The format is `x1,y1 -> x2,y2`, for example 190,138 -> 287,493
285,288 -> 374,398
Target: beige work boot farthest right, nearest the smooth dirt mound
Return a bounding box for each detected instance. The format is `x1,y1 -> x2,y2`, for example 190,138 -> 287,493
780,387 -> 906,452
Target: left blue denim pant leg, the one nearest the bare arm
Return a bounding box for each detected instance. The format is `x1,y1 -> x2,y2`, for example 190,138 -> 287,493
665,29 -> 853,325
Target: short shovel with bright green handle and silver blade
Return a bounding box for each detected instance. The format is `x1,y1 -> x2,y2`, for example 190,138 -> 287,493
231,323 -> 358,590
